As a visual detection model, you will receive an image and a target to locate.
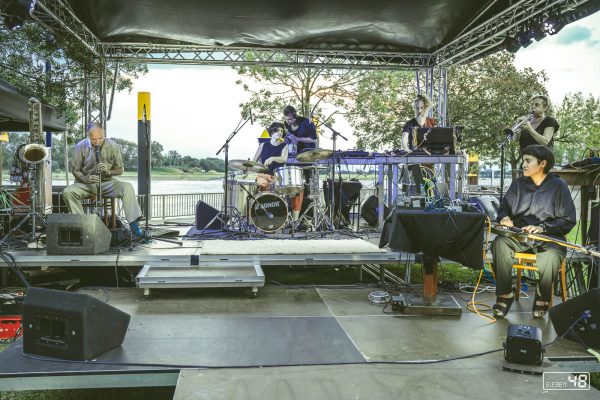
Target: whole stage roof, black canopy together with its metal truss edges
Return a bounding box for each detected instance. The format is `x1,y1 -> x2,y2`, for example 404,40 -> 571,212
25,0 -> 600,68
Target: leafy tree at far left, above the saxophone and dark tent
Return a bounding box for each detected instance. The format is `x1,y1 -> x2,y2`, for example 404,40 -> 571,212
0,17 -> 147,136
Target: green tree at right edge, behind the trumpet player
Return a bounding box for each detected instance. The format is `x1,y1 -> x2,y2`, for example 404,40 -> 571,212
554,92 -> 600,164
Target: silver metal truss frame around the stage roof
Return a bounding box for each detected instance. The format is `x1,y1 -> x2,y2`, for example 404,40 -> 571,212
24,0 -> 588,126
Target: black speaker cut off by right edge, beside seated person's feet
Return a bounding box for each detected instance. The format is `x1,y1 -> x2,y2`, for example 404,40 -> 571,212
549,288 -> 600,349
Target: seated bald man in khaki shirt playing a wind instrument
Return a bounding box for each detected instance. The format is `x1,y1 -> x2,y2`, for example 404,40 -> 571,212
63,123 -> 142,236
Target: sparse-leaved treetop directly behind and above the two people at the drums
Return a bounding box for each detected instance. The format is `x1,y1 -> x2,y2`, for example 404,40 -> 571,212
233,59 -> 364,126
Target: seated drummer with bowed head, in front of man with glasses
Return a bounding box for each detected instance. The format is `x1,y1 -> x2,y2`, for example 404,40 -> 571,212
254,122 -> 288,191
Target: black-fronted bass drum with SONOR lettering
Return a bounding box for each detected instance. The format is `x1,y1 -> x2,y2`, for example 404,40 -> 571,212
250,192 -> 288,232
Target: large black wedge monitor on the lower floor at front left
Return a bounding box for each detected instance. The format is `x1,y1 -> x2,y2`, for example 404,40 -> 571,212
23,287 -> 131,361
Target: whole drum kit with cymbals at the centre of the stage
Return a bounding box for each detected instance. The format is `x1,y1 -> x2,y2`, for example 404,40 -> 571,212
227,149 -> 334,233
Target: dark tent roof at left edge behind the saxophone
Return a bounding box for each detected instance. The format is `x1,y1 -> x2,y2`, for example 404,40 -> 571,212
0,80 -> 67,132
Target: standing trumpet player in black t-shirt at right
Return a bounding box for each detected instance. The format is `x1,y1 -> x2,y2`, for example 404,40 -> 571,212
512,95 -> 559,154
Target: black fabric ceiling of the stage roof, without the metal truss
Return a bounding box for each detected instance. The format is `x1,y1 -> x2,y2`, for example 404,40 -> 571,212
68,0 -> 482,52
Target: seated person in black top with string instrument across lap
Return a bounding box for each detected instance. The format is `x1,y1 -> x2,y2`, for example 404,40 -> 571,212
492,145 -> 577,318
